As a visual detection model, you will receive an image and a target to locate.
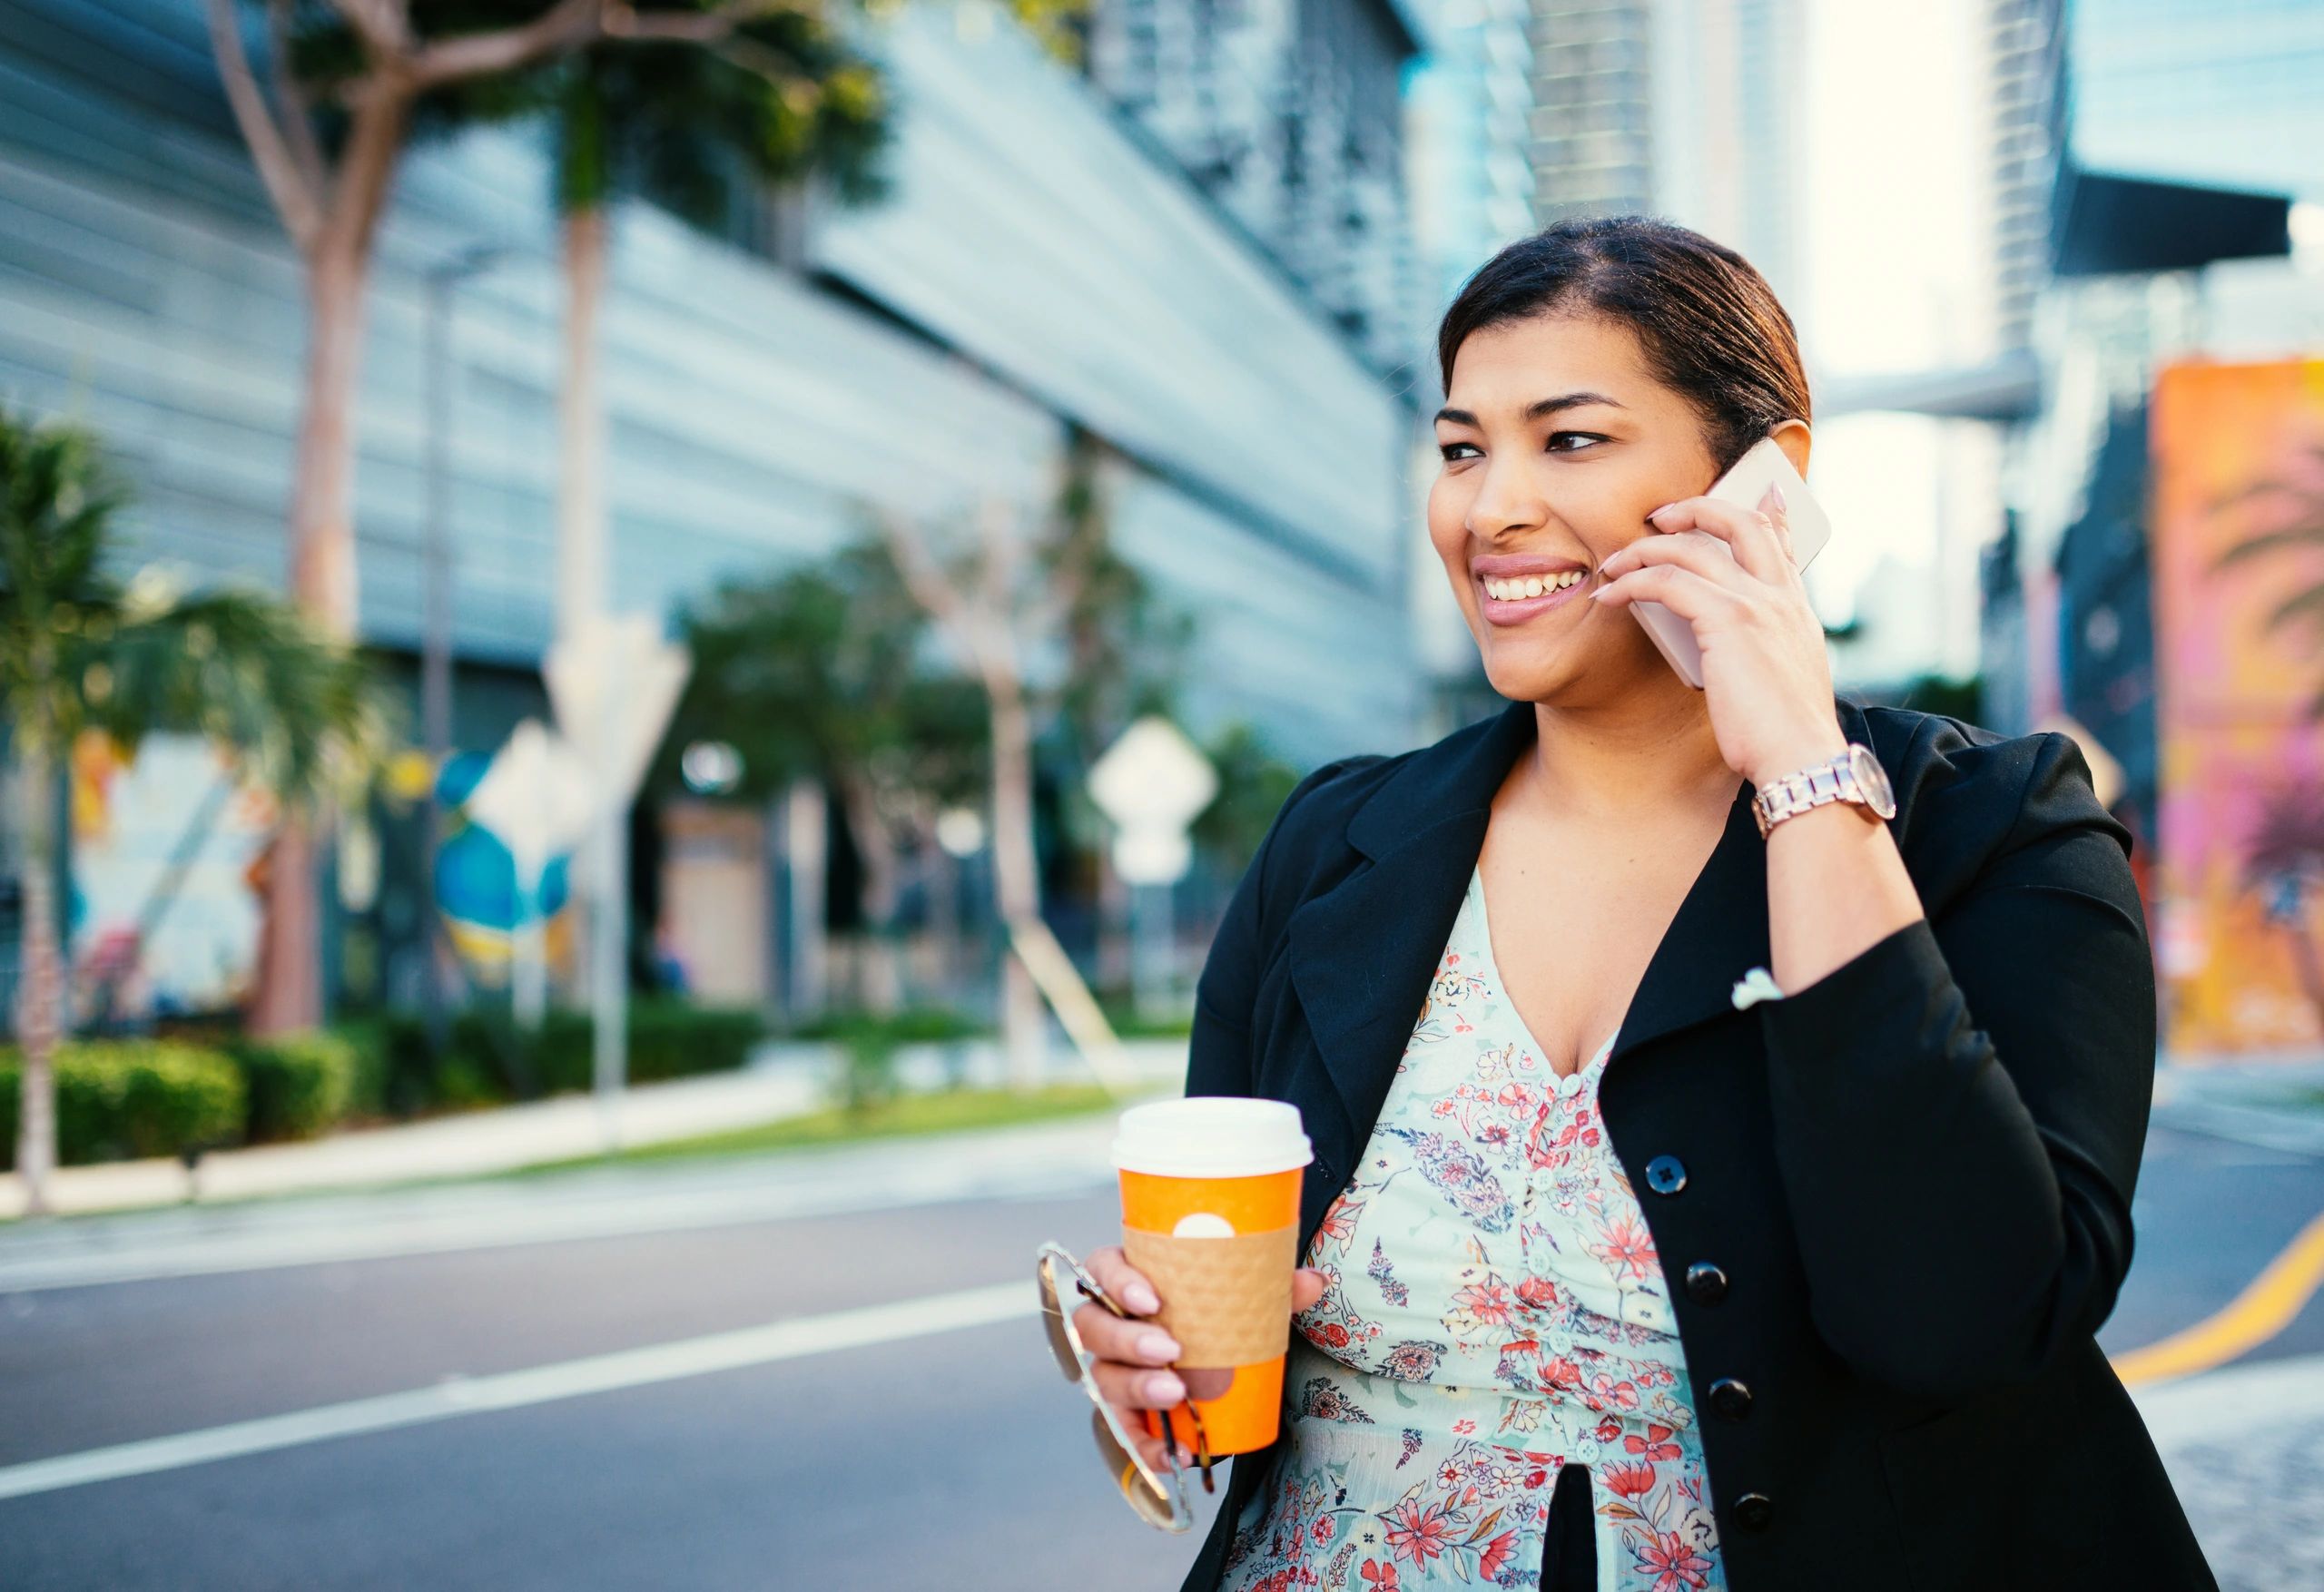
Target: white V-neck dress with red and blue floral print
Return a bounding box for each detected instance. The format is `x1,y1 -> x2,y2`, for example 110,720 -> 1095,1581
1220,874 -> 1727,1592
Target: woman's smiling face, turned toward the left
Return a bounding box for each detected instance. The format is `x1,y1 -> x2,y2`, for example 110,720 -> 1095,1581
1429,314 -> 1718,706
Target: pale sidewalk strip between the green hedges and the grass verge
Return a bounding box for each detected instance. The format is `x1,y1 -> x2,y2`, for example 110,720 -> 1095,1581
0,1039 -> 1186,1220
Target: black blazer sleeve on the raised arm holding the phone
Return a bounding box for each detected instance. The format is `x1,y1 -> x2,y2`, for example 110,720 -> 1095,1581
1759,734 -> 2154,1399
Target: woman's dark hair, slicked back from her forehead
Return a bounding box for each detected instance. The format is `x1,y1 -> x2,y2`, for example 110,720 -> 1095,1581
1436,216 -> 1810,469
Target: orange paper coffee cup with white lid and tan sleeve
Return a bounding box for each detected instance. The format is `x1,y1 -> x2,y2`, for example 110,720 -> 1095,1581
1113,1095 -> 1315,1455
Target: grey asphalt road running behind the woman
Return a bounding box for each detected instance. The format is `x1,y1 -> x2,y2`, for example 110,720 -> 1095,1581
0,1115 -> 2324,1592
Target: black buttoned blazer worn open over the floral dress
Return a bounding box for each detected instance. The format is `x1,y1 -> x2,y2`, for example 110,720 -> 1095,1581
1186,702 -> 2215,1592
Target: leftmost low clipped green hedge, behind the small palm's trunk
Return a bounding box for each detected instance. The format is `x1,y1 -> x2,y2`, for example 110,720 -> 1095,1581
0,1039 -> 244,1169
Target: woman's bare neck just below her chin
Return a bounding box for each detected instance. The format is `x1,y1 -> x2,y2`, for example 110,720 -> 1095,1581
1527,672 -> 1740,816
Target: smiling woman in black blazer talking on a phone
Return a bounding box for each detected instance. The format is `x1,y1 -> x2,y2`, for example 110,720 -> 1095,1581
1076,219 -> 2215,1592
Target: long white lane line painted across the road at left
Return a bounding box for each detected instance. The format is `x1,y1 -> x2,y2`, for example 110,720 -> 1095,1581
0,1278 -> 1039,1499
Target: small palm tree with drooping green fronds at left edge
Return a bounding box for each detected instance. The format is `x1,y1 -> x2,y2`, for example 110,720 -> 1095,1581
0,409 -> 383,1214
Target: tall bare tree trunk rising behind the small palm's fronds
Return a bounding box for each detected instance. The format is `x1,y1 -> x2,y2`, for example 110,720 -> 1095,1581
251,95 -> 409,1034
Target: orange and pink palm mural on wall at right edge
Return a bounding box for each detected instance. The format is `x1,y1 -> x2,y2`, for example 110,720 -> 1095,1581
2152,360 -> 2324,1060
